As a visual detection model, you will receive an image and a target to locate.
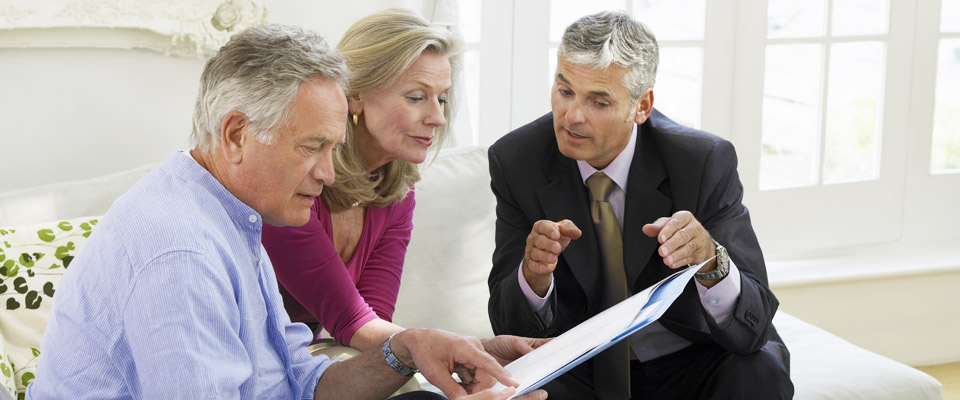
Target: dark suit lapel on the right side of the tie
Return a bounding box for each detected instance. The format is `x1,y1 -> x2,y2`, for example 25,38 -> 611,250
620,121 -> 673,289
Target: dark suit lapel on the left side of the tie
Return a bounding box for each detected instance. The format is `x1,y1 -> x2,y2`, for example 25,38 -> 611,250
537,145 -> 600,306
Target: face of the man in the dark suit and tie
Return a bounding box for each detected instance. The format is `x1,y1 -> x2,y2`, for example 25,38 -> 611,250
550,57 -> 646,169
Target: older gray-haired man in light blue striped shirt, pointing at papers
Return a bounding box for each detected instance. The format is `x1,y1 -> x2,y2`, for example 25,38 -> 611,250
27,25 -> 545,399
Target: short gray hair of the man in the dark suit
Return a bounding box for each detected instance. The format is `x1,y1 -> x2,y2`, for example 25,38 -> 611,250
557,11 -> 660,100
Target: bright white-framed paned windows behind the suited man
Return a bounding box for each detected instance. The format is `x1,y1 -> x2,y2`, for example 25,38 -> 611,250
461,0 -> 960,260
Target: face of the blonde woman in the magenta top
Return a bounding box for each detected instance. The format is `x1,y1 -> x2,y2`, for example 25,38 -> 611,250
350,52 -> 451,170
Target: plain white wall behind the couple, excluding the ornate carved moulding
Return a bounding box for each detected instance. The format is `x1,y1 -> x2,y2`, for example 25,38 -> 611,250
0,0 -> 434,194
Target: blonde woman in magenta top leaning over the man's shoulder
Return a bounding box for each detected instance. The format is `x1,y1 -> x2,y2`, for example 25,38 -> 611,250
263,10 -> 543,388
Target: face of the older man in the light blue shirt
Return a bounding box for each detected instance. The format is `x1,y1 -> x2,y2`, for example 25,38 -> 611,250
238,80 -> 347,226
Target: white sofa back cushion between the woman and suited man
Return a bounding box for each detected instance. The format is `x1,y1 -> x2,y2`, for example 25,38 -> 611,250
393,147 -> 496,337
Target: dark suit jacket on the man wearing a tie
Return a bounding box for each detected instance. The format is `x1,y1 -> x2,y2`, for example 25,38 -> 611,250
488,110 -> 789,365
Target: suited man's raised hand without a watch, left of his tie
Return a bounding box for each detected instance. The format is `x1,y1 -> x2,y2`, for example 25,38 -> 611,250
522,219 -> 583,297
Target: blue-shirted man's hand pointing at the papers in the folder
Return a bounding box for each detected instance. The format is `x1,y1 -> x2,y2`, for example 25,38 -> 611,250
390,329 -> 519,399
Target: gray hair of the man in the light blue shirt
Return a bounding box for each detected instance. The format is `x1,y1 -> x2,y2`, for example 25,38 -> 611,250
190,24 -> 349,151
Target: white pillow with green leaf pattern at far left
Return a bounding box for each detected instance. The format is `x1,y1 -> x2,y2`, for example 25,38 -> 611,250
0,217 -> 99,399
